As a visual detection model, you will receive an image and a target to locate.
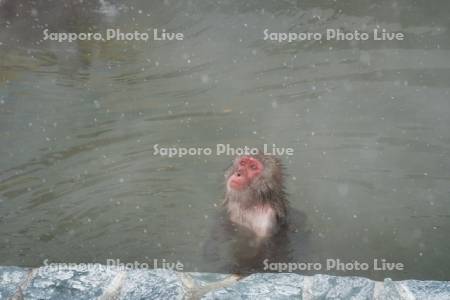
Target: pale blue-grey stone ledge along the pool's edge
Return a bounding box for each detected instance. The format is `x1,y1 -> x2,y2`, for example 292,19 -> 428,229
0,265 -> 450,300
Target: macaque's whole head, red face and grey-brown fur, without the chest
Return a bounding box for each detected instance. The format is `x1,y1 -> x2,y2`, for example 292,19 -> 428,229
225,154 -> 283,193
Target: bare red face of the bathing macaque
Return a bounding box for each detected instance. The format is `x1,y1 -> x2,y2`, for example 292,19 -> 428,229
228,156 -> 264,190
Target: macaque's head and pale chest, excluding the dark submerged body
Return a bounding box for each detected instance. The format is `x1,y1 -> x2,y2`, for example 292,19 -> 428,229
224,154 -> 288,239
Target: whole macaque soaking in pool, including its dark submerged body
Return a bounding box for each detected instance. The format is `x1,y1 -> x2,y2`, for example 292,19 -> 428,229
204,154 -> 307,274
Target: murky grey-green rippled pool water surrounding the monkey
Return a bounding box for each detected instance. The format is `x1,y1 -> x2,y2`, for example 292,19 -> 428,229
0,0 -> 450,280
